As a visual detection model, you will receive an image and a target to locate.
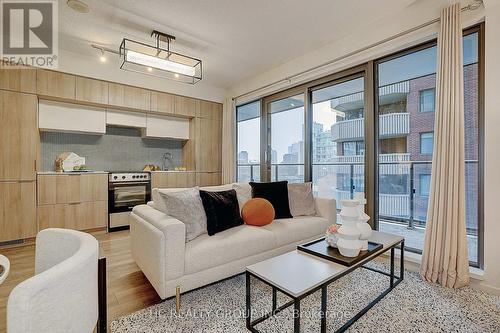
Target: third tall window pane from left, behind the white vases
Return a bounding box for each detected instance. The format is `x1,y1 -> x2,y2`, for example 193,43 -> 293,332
311,76 -> 365,208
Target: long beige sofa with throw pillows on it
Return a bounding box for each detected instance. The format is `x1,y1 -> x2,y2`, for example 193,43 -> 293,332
130,184 -> 337,299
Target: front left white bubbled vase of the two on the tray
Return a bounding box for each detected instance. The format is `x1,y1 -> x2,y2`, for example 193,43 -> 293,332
337,200 -> 361,257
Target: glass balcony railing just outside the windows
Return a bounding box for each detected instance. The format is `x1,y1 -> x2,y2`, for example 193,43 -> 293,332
238,159 -> 478,234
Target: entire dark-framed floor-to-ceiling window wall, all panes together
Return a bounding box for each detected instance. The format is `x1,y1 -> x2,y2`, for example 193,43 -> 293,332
238,26 -> 484,266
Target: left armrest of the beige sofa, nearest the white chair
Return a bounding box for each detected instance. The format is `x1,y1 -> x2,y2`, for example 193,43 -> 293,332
130,205 -> 186,299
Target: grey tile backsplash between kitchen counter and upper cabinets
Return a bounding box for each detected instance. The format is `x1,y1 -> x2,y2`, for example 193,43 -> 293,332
41,127 -> 183,171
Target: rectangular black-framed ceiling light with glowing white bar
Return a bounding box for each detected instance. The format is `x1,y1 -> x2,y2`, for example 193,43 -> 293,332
120,30 -> 202,84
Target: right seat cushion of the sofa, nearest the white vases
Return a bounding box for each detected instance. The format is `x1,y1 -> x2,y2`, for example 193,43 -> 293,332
261,216 -> 330,247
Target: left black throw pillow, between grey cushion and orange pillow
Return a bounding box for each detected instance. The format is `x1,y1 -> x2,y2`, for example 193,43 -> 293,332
200,190 -> 243,236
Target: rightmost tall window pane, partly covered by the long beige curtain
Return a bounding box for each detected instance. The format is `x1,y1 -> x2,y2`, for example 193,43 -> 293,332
376,27 -> 479,265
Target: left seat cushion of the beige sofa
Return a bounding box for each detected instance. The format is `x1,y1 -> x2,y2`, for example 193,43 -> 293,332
184,225 -> 276,274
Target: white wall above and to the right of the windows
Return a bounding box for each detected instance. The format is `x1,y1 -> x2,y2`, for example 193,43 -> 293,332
231,0 -> 500,295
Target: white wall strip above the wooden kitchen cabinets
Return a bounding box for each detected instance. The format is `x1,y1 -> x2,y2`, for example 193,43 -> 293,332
57,49 -> 227,102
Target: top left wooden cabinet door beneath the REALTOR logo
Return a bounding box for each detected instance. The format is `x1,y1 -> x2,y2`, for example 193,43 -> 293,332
0,67 -> 36,94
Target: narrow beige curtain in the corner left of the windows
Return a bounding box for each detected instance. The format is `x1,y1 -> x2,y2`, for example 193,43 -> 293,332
222,98 -> 236,184
